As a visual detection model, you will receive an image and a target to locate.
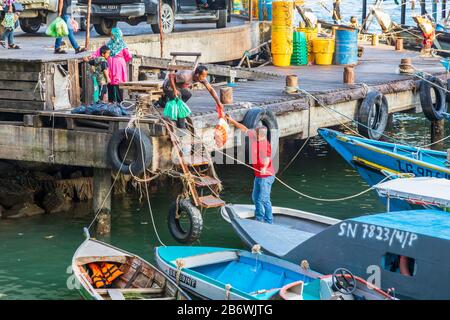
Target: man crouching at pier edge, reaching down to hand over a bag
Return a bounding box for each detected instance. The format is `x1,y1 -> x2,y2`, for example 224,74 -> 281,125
162,66 -> 224,129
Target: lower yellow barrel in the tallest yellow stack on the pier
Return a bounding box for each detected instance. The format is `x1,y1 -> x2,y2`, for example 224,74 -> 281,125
271,26 -> 294,67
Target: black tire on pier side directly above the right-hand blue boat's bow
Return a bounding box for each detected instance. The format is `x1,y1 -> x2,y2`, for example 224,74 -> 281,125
358,91 -> 389,140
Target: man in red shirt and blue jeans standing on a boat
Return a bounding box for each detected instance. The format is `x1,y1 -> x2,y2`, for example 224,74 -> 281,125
227,116 -> 275,224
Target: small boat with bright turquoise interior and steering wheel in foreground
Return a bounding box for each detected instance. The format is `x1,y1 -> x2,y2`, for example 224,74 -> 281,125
155,247 -> 392,300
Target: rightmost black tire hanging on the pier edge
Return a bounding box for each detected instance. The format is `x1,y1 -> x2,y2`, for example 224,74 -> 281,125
419,77 -> 447,121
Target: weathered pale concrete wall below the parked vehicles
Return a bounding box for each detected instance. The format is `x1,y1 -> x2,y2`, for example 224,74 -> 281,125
91,22 -> 268,63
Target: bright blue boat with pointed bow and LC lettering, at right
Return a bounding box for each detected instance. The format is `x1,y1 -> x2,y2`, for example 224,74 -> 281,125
318,129 -> 450,211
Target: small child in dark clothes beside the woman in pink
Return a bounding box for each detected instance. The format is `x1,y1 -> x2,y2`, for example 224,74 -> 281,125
83,45 -> 111,103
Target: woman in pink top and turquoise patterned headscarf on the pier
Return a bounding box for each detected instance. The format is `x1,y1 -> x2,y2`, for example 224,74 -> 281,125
92,28 -> 133,102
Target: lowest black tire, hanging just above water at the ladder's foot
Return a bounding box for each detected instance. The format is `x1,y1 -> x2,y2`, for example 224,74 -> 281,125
167,199 -> 203,244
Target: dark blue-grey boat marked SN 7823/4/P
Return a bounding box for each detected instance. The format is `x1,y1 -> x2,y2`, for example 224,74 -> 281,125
221,205 -> 450,300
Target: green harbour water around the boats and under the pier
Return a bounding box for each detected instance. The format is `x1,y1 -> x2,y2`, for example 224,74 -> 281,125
0,115 -> 450,299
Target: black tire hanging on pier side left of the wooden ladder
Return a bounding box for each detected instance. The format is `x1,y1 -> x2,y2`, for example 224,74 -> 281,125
107,128 -> 153,175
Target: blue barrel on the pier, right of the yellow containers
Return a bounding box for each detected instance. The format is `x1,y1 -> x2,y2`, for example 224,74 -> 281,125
334,29 -> 358,65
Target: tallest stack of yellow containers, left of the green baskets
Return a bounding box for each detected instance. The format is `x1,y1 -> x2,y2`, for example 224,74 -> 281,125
272,0 -> 294,67
